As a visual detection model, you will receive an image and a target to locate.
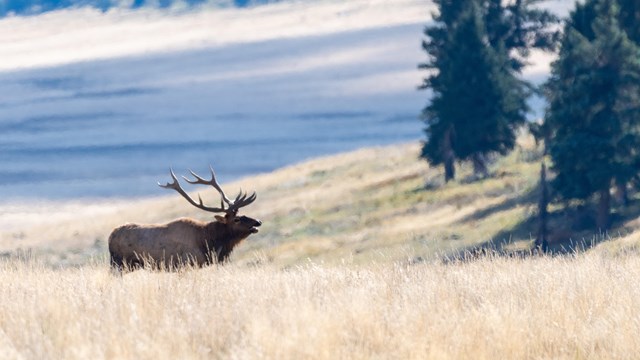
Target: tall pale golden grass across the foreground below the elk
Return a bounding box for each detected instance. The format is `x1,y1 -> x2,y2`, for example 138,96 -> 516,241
0,254 -> 640,359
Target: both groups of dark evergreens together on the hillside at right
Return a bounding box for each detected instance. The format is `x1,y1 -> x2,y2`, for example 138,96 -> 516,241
420,0 -> 640,230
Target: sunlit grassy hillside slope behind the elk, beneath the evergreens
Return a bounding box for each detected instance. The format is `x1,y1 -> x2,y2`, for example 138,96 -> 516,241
0,141 -> 640,266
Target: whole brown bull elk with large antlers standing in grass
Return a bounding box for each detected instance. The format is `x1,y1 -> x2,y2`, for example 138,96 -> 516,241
109,166 -> 262,270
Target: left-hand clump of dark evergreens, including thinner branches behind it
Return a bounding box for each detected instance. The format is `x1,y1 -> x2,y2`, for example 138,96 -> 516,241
420,0 -> 557,181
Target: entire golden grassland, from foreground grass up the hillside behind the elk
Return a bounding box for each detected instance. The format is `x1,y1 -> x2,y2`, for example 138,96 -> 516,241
0,138 -> 640,359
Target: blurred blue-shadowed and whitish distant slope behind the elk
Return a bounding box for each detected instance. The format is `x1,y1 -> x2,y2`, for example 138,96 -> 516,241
0,0 -> 566,200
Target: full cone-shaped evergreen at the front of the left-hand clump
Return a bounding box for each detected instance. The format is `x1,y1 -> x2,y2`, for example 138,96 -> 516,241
423,2 -> 526,179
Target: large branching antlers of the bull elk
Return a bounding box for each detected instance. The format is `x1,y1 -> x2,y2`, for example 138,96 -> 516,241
158,165 -> 257,214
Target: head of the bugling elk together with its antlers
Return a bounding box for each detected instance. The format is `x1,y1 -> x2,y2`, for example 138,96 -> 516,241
158,166 -> 262,236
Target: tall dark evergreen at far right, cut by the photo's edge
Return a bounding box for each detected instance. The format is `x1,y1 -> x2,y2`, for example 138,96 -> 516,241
545,0 -> 640,229
